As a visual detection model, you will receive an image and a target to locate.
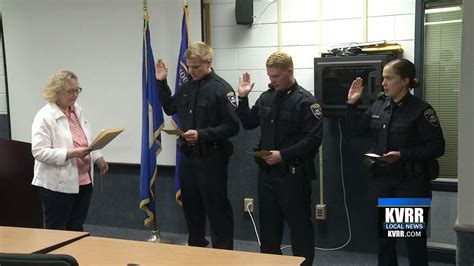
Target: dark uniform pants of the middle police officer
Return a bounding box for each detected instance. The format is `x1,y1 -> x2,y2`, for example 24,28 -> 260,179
258,167 -> 314,265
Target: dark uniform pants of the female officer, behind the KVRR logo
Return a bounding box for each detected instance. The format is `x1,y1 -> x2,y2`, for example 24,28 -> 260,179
371,176 -> 432,266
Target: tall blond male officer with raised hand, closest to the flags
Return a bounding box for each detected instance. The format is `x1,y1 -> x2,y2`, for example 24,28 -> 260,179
156,42 -> 239,249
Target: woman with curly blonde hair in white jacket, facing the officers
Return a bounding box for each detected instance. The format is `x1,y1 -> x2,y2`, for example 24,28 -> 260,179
31,70 -> 109,231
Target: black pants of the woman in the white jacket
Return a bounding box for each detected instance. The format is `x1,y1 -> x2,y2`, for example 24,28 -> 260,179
38,184 -> 92,231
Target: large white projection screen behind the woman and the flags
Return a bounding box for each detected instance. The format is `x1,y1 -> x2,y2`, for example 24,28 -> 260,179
0,0 -> 201,165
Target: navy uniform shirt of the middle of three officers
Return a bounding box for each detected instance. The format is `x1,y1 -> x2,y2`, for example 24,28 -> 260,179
237,81 -> 322,161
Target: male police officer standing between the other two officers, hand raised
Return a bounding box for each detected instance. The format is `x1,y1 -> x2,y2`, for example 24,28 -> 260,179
237,52 -> 322,265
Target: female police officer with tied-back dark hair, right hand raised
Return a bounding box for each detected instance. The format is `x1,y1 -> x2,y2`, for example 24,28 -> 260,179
347,59 -> 445,265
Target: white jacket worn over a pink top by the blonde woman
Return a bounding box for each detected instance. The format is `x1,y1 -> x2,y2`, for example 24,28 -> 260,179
31,103 -> 102,193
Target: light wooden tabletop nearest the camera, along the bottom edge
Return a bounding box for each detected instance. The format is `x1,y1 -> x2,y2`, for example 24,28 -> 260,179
50,237 -> 304,265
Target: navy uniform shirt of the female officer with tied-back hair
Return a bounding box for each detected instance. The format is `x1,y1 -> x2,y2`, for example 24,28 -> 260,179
346,93 -> 445,161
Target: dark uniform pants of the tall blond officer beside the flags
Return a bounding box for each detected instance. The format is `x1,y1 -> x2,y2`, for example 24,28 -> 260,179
180,151 -> 234,249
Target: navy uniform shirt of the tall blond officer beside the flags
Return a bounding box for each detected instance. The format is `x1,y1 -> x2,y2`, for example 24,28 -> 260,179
158,70 -> 239,143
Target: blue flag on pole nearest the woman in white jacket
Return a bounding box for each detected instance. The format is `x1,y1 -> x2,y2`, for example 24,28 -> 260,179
140,10 -> 164,226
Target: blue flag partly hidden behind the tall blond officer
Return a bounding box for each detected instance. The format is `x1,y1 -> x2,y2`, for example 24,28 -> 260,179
172,5 -> 189,205
